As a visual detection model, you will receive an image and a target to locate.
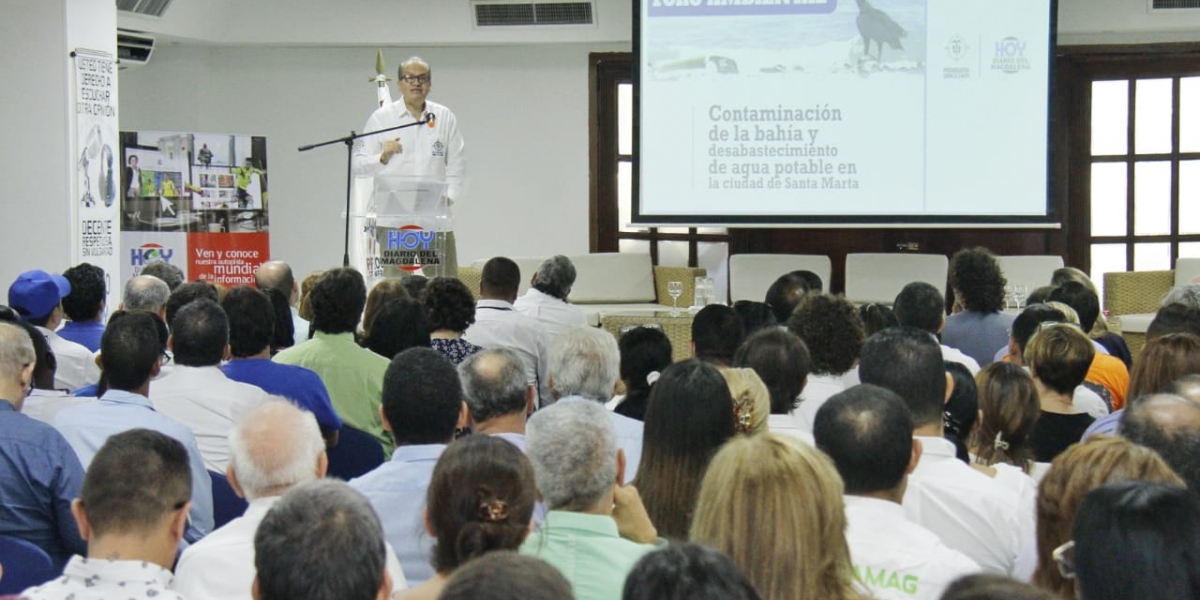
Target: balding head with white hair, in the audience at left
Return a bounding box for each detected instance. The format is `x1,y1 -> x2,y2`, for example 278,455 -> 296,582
228,396 -> 328,500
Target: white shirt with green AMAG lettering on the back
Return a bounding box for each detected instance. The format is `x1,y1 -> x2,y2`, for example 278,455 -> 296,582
846,496 -> 982,600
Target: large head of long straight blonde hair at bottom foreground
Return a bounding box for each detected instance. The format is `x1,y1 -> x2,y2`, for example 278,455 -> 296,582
690,433 -> 865,600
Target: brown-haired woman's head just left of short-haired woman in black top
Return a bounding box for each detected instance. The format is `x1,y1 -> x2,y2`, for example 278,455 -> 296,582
971,362 -> 1045,476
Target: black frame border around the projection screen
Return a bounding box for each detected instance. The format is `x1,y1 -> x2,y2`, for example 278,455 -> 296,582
629,0 -> 1066,229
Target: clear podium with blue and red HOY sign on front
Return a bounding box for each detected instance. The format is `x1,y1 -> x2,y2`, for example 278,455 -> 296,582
349,178 -> 454,287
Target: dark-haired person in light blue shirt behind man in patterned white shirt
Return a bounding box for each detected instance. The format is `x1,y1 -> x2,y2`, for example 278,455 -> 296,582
54,311 -> 212,541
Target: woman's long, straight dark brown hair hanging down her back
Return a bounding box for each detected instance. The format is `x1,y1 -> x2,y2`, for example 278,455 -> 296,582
634,360 -> 736,540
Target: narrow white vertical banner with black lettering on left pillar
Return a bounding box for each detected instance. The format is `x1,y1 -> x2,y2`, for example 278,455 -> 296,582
71,48 -> 121,307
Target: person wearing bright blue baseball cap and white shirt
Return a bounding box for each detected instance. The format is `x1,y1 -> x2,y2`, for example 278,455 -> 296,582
8,270 -> 100,391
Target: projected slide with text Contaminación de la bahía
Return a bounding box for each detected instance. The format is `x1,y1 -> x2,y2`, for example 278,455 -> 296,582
635,0 -> 1052,222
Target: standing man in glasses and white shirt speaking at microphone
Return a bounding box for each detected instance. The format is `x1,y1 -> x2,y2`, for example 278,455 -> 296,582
354,56 -> 467,277
